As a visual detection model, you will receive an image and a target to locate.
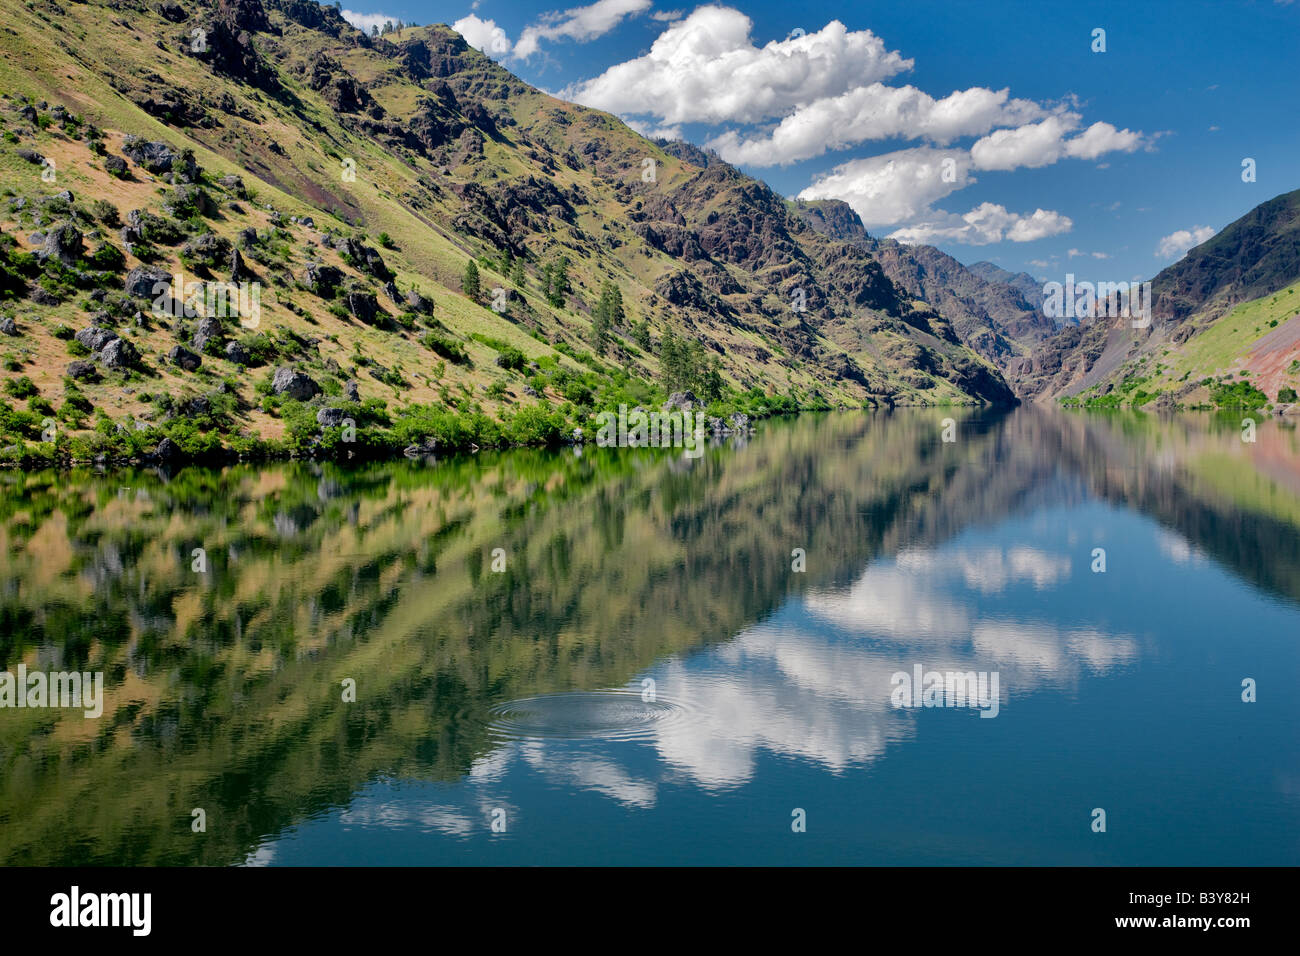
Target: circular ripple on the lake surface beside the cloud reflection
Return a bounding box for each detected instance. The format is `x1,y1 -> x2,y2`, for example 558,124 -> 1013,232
489,691 -> 685,740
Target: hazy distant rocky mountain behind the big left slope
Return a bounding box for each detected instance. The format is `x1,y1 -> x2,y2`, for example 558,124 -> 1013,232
792,199 -> 1056,367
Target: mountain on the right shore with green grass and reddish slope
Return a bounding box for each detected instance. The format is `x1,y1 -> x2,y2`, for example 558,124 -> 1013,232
1005,190 -> 1300,407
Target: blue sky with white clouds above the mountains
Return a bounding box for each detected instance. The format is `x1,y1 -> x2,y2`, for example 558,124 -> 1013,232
343,0 -> 1300,282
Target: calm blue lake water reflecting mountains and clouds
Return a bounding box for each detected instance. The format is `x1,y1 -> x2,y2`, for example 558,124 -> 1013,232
0,410 -> 1300,865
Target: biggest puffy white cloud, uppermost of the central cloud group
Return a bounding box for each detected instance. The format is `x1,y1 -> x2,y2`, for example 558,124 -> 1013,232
562,7 -> 913,124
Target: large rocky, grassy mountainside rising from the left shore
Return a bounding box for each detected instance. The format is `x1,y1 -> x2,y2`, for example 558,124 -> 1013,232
0,0 -> 1014,460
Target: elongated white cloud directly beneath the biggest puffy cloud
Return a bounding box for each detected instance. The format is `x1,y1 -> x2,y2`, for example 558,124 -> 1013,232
709,83 -> 1044,166
